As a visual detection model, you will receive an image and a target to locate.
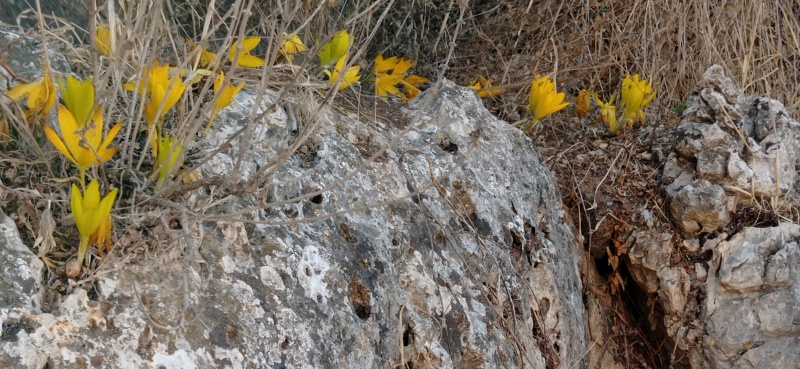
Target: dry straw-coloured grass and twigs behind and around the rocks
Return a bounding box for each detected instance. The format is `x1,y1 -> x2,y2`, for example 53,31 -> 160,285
0,0 -> 800,367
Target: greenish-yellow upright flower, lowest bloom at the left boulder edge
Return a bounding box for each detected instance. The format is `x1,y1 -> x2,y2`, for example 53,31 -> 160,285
70,179 -> 117,265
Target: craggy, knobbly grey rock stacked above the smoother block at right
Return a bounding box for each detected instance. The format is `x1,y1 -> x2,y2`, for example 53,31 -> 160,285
662,65 -> 800,235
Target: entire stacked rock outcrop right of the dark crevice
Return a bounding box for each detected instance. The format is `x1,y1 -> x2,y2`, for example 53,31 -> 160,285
627,66 -> 800,369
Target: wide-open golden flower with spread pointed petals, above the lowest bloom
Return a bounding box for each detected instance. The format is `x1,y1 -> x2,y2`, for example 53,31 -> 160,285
44,105 -> 122,172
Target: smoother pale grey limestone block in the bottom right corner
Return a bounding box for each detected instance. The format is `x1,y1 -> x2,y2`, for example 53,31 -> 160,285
690,224 -> 800,368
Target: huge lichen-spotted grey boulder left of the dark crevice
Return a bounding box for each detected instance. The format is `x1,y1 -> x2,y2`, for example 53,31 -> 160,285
0,77 -> 588,369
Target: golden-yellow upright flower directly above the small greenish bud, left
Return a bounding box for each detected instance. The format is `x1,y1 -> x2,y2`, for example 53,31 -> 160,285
139,64 -> 186,127
